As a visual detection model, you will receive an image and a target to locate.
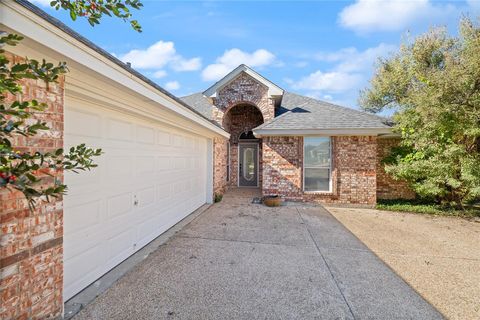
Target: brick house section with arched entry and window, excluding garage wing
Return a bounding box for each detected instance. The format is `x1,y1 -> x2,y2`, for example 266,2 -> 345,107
182,65 -> 409,205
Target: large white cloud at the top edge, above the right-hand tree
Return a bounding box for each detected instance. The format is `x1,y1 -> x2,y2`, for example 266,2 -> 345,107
339,0 -> 456,32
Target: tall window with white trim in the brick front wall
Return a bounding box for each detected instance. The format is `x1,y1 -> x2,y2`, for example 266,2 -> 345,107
303,137 -> 332,192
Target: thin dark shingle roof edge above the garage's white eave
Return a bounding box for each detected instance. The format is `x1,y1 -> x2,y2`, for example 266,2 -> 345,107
15,0 -> 221,127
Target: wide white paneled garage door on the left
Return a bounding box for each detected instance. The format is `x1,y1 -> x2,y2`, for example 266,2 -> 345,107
64,99 -> 207,300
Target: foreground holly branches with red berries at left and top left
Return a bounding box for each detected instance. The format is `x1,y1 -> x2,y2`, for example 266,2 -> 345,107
0,0 -> 142,209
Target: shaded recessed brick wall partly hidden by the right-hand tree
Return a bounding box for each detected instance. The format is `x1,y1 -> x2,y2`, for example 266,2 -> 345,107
377,138 -> 415,199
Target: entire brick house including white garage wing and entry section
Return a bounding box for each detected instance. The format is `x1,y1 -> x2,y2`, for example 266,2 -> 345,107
0,0 -> 408,319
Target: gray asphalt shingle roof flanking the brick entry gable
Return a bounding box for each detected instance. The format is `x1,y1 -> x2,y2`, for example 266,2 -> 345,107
181,92 -> 391,130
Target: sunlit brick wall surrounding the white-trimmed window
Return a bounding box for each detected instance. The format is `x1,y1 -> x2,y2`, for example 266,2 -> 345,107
262,136 -> 377,205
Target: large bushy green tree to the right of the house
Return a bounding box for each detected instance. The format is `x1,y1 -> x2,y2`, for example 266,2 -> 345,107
360,18 -> 480,208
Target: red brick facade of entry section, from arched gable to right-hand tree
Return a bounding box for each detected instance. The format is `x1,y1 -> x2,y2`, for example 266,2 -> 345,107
207,72 -> 413,205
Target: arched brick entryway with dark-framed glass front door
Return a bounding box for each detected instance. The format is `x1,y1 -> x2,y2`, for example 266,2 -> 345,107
223,103 -> 263,187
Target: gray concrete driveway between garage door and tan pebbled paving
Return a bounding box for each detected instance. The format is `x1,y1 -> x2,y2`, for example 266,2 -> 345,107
75,189 -> 442,320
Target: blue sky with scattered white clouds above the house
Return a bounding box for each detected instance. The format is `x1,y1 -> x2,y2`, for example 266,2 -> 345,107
33,0 -> 480,108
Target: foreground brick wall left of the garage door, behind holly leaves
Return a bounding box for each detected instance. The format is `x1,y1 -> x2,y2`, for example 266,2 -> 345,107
0,55 -> 64,319
